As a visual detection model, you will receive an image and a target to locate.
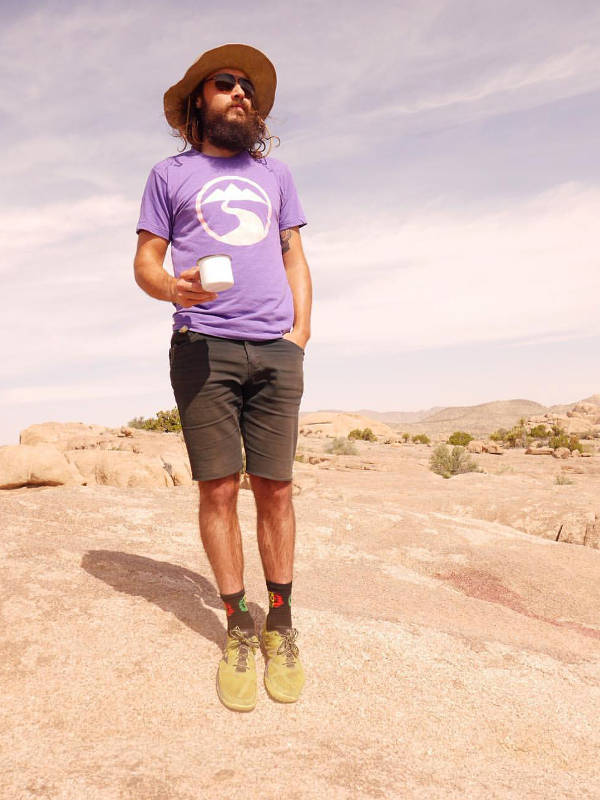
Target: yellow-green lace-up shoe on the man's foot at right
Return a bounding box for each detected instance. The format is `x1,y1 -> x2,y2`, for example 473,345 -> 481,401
261,624 -> 304,703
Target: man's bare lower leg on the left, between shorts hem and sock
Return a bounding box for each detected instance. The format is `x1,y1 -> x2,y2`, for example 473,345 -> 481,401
198,473 -> 244,594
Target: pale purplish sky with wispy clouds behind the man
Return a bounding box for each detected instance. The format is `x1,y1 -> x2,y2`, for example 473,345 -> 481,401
0,0 -> 600,444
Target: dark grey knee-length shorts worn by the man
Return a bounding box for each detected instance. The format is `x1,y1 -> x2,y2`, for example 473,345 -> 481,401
169,331 -> 304,481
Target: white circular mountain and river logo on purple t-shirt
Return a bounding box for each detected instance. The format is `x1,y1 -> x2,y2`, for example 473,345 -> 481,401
196,175 -> 272,245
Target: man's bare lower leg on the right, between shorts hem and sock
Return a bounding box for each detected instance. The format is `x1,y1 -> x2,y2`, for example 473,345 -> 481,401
250,475 -> 296,583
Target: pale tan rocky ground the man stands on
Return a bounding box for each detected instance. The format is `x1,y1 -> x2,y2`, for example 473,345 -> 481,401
0,432 -> 600,800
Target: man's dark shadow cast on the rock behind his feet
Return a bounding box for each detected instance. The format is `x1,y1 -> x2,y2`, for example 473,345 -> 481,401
81,550 -> 265,647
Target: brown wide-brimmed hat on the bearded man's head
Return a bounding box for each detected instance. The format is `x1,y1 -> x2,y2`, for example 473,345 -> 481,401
164,44 -> 277,128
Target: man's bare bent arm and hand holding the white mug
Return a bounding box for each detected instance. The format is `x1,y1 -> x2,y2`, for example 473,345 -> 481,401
133,230 -> 217,308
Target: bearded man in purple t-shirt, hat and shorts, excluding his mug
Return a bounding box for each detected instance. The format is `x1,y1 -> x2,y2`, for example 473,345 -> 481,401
134,44 -> 312,711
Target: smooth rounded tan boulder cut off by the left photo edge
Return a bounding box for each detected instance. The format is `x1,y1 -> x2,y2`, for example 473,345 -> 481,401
0,444 -> 85,489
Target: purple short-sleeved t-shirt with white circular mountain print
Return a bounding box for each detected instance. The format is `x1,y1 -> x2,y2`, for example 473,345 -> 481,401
137,150 -> 306,340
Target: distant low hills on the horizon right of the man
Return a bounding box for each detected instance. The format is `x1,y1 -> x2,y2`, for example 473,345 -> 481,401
314,394 -> 600,437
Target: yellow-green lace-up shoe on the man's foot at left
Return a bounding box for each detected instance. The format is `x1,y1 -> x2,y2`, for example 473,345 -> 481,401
217,626 -> 260,711
